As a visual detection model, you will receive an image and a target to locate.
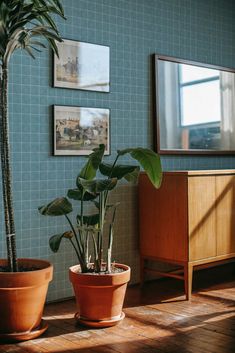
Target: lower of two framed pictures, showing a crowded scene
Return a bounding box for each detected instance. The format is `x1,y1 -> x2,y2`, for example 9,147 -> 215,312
53,105 -> 110,156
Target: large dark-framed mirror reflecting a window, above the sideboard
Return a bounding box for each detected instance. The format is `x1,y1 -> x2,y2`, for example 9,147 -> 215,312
154,55 -> 235,154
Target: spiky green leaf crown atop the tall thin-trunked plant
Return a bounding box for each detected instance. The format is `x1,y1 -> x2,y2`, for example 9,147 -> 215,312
0,0 -> 65,66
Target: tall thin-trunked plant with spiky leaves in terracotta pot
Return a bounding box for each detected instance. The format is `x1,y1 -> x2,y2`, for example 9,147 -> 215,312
0,0 -> 64,341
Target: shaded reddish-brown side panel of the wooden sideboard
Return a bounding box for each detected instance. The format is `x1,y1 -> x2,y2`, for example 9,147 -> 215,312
139,174 -> 188,261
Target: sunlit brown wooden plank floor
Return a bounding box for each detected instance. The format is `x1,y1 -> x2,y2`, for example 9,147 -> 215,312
0,264 -> 235,353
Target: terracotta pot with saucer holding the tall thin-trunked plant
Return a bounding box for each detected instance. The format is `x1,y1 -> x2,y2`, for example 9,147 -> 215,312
0,259 -> 53,341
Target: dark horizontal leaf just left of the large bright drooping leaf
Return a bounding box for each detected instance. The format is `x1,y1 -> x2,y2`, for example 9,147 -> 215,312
99,163 -> 139,181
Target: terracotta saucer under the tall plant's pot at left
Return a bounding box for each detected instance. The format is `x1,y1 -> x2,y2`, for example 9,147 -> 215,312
0,320 -> 48,342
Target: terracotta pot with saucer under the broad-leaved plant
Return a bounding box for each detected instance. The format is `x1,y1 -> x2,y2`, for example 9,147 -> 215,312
69,264 -> 130,327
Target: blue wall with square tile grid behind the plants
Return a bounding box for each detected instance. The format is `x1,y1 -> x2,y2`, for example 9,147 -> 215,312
0,0 -> 235,299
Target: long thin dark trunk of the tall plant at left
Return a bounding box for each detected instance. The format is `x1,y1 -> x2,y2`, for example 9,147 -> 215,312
0,64 -> 18,272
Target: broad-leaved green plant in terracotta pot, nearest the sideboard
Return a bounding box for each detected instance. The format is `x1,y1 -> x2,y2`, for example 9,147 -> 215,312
39,145 -> 162,327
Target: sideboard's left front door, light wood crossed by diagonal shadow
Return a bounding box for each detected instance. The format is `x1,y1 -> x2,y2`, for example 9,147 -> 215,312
188,176 -> 216,261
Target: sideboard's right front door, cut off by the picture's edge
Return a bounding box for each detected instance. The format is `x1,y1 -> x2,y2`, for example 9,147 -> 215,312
216,175 -> 235,255
